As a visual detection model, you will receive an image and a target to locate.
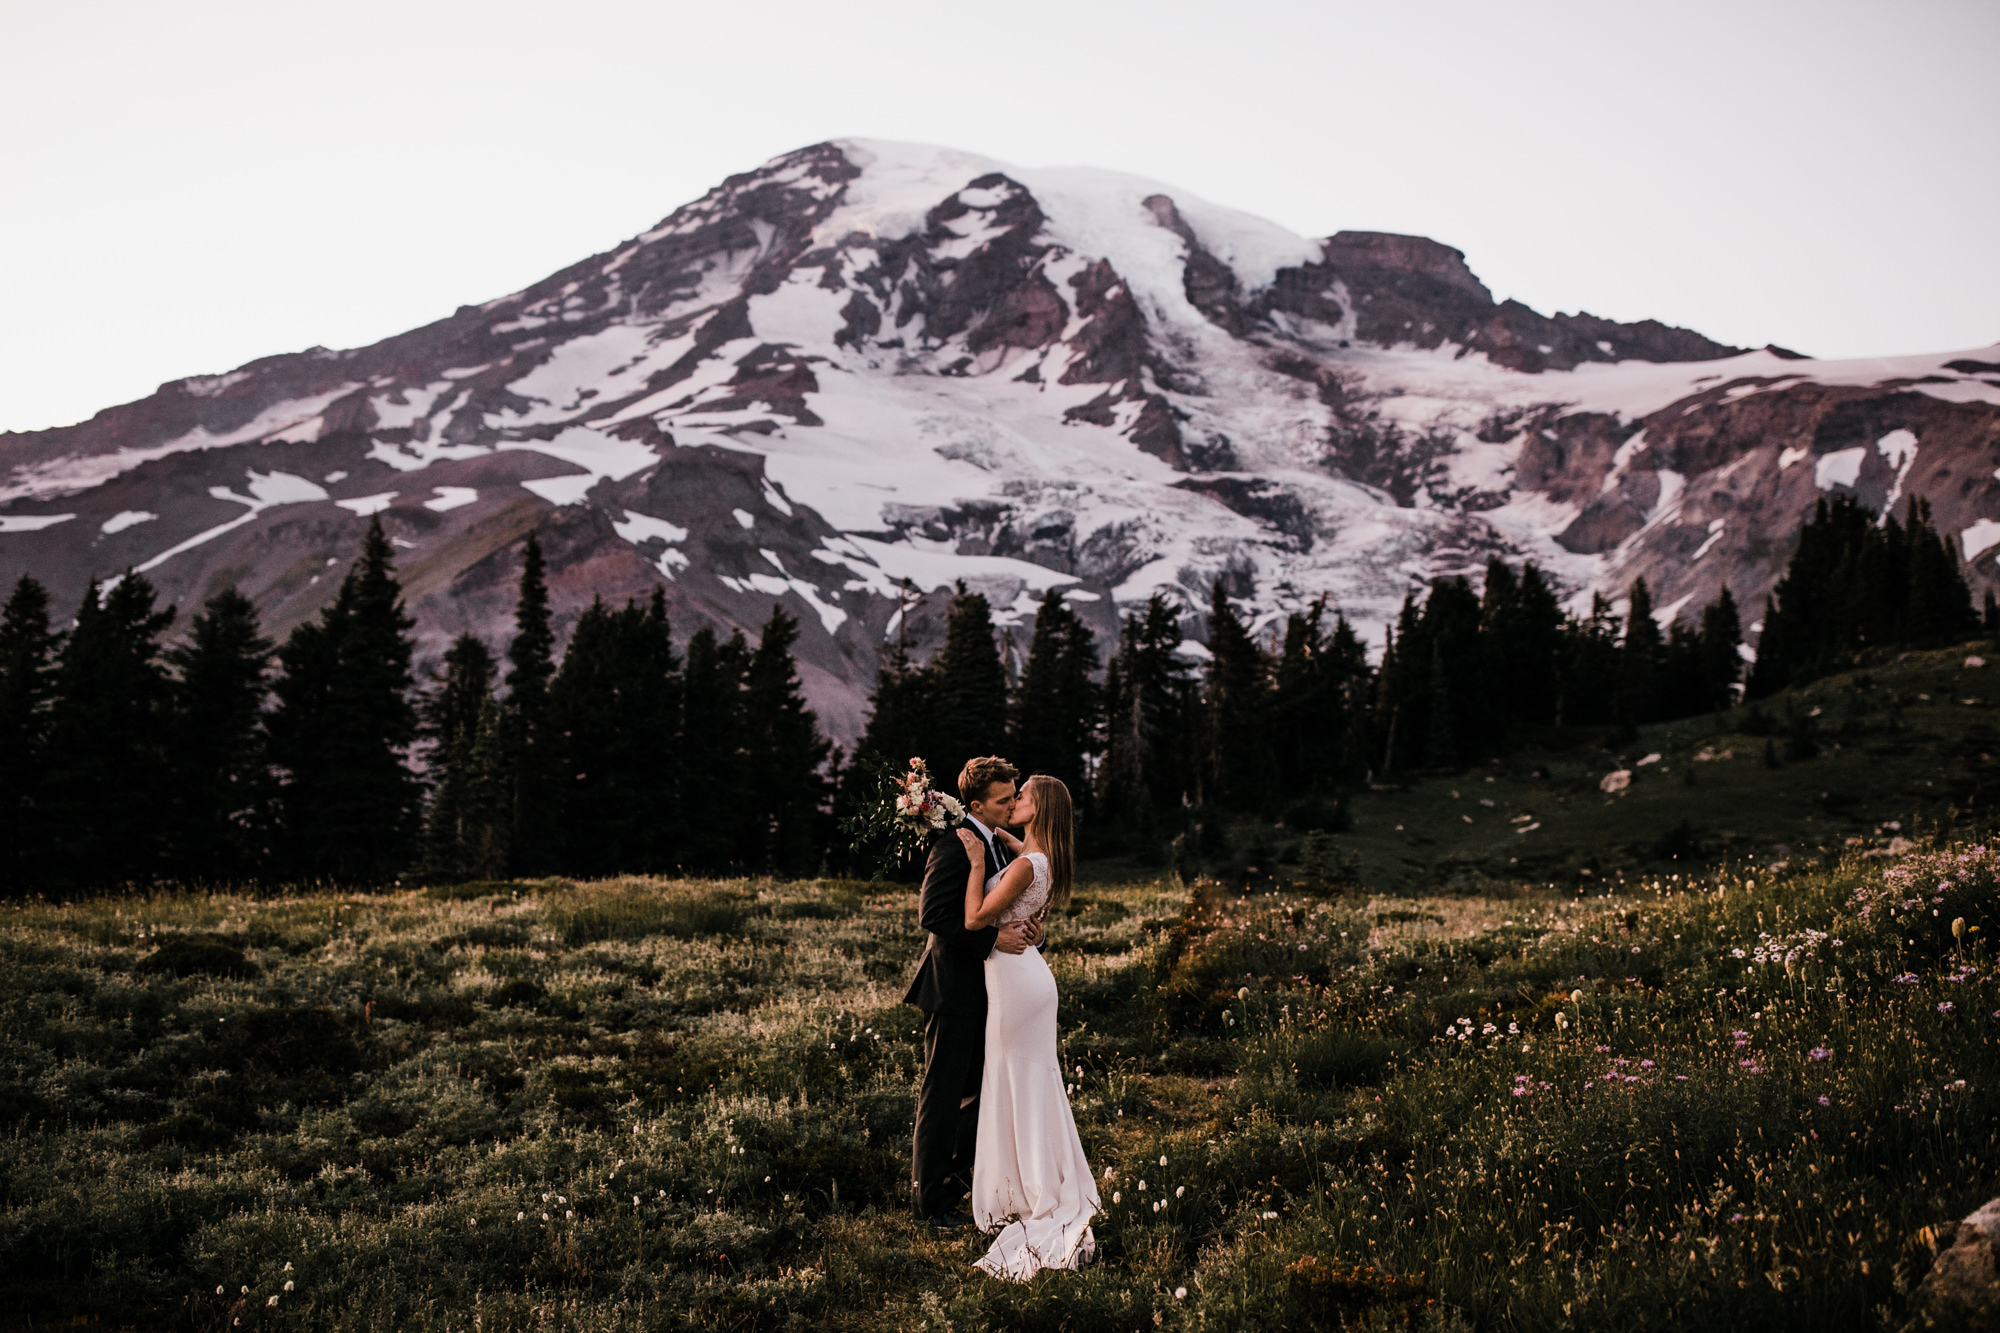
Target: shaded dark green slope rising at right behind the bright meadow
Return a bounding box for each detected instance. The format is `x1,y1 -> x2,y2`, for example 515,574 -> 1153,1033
1184,642 -> 2000,891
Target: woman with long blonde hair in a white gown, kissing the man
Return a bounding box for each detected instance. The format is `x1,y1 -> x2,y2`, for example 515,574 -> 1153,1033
958,775 -> 1102,1281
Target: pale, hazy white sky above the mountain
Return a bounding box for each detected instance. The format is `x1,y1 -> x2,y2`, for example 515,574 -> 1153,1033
0,0 -> 2000,430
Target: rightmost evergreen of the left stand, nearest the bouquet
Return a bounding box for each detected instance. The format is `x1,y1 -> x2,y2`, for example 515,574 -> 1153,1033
742,606 -> 832,875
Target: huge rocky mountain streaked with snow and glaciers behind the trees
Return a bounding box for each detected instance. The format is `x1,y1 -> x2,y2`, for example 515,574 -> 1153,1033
0,140 -> 2000,737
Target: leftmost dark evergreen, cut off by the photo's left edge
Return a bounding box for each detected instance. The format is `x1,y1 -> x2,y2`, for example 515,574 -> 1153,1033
0,574 -> 62,889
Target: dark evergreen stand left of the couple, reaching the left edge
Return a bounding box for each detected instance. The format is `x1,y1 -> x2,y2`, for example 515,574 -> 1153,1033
0,520 -> 832,893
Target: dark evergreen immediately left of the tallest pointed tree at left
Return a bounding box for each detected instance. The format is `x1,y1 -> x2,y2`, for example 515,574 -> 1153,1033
166,588 -> 274,883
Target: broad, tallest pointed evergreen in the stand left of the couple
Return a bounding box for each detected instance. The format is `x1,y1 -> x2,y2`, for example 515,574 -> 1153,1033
270,516 -> 420,885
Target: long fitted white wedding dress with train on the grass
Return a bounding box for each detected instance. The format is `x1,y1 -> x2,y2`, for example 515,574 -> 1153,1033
972,853 -> 1102,1281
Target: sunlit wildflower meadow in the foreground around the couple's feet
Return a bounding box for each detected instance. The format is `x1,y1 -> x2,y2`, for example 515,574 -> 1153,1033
0,832 -> 2000,1333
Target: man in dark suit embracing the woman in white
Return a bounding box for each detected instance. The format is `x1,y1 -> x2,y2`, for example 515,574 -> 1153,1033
904,757 -> 1042,1227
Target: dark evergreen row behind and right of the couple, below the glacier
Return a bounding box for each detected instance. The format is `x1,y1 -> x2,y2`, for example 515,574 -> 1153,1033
852,560 -> 1742,837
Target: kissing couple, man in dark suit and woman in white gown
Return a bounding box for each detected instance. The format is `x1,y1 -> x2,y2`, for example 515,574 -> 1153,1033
904,757 -> 1102,1281
